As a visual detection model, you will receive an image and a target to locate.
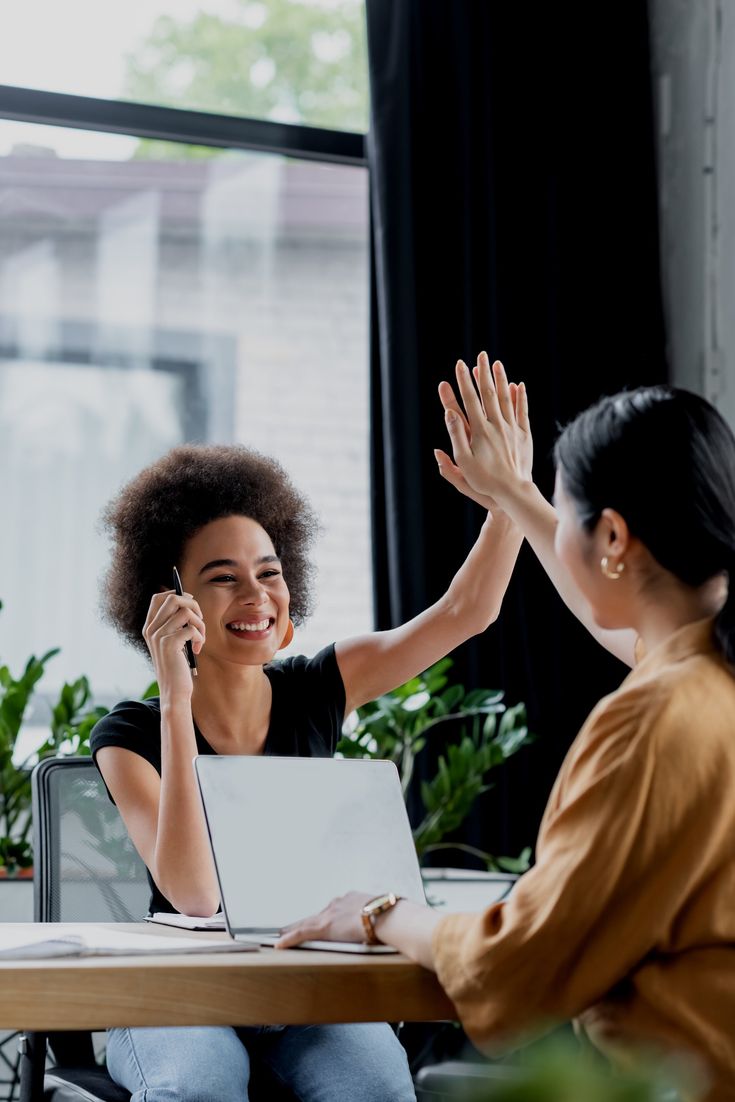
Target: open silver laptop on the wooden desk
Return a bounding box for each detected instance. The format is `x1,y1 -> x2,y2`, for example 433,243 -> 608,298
194,754 -> 425,953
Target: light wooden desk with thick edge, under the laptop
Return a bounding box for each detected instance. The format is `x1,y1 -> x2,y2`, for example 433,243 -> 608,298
0,922 -> 456,1030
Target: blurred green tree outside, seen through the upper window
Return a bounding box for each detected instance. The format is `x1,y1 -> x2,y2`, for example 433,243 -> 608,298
125,0 -> 368,159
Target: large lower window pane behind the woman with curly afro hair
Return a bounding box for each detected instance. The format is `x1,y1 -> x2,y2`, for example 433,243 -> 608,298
0,109 -> 371,722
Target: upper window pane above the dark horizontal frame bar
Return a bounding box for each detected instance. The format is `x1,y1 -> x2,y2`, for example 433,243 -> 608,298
0,0 -> 368,131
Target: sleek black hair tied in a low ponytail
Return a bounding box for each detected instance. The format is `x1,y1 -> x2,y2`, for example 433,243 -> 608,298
554,387 -> 735,663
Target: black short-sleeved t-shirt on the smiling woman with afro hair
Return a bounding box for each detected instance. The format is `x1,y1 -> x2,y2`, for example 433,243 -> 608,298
89,645 -> 345,912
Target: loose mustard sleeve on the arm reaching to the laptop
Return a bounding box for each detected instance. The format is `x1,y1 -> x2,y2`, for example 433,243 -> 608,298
433,690 -> 696,1052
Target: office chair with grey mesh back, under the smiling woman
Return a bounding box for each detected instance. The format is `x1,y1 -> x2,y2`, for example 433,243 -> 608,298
20,757 -> 294,1102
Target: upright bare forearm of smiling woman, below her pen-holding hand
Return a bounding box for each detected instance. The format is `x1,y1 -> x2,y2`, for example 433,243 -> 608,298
151,702 -> 219,915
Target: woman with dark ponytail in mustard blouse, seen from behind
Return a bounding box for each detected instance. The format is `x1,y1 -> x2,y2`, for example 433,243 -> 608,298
282,356 -> 735,1102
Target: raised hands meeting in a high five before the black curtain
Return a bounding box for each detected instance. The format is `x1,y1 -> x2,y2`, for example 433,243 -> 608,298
434,353 -> 533,509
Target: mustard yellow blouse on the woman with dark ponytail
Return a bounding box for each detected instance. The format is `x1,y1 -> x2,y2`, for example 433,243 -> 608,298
433,620 -> 735,1102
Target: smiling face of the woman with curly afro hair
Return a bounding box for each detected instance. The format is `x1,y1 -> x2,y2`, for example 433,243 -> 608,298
181,517 -> 289,666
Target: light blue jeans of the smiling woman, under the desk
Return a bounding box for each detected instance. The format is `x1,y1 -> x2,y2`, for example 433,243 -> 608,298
107,1023 -> 415,1102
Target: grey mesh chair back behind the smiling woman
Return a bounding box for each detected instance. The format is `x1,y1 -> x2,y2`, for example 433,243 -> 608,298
32,757 -> 150,922
